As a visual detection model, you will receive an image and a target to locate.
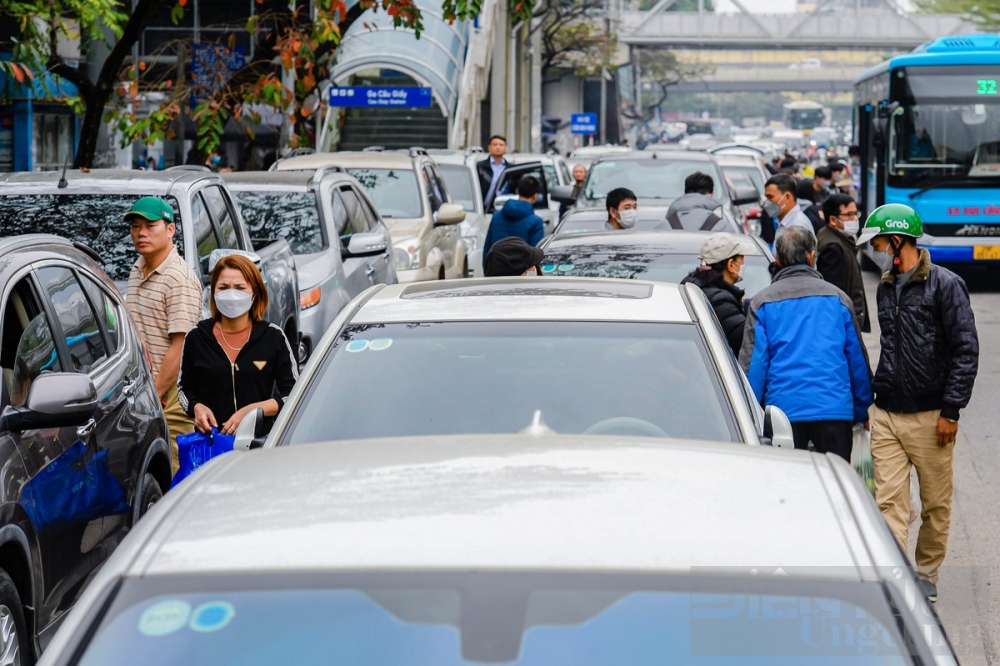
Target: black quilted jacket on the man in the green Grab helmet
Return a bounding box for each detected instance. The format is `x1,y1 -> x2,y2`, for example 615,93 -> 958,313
872,250 -> 979,419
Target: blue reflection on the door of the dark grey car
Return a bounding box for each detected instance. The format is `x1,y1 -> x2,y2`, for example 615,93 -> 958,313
21,439 -> 130,531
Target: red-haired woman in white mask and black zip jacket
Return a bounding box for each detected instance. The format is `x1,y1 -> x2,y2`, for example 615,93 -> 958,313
177,254 -> 298,435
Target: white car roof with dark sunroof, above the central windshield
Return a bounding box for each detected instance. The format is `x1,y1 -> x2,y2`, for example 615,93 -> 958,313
351,277 -> 693,324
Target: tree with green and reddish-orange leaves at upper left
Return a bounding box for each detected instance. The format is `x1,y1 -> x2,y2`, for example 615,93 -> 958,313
0,0 -> 516,167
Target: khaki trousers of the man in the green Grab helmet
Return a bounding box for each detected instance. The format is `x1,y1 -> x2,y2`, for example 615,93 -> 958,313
870,406 -> 955,585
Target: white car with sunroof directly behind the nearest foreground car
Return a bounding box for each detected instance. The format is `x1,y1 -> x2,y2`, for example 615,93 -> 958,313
230,274 -> 792,446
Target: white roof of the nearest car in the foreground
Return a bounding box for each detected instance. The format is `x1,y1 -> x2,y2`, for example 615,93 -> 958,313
118,435 -> 868,580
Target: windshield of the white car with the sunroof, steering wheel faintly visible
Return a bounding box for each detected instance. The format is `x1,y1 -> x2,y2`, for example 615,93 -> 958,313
282,320 -> 739,444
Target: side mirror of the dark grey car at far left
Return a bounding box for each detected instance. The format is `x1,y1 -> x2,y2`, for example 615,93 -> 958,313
0,372 -> 97,432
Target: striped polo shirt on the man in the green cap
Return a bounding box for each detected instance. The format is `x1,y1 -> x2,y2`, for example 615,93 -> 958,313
125,247 -> 202,377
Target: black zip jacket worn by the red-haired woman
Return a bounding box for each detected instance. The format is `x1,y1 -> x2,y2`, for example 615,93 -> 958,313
177,319 -> 298,430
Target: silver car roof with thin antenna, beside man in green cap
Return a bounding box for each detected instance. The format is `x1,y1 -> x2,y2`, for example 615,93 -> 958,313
0,169 -> 220,196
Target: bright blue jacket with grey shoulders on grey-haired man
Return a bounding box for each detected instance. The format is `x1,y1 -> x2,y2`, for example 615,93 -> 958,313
740,264 -> 872,423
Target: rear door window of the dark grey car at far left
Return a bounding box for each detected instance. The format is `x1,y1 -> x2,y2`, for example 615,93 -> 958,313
38,266 -> 108,372
